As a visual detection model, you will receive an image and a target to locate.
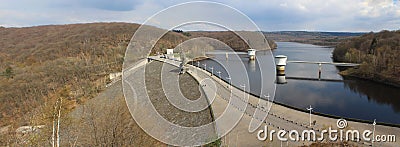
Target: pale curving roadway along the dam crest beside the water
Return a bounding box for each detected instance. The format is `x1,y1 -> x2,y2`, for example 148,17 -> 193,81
131,57 -> 400,146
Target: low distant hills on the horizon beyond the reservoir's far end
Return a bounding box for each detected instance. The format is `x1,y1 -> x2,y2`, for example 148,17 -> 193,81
264,31 -> 365,46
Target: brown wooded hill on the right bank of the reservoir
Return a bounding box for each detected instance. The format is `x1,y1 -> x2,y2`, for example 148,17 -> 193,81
333,31 -> 400,87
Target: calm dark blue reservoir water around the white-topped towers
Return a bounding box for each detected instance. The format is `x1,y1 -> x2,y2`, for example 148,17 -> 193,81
195,42 -> 400,124
